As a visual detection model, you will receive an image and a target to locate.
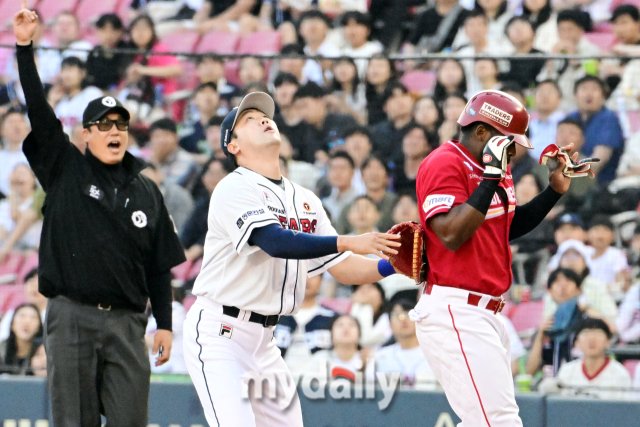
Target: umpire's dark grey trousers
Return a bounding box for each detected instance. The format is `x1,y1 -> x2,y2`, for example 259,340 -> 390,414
45,296 -> 151,427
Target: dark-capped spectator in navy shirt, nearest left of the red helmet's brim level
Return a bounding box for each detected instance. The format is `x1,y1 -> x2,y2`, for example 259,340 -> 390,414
371,83 -> 415,160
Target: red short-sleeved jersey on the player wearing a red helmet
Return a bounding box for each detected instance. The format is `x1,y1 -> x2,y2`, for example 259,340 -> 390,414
416,140 -> 516,296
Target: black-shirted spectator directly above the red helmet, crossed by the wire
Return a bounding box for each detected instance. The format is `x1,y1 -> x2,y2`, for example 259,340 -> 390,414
498,16 -> 545,88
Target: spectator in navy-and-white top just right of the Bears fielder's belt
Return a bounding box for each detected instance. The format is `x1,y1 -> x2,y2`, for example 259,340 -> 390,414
273,275 -> 336,378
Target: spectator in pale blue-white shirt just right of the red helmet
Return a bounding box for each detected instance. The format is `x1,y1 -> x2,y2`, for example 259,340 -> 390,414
529,79 -> 565,160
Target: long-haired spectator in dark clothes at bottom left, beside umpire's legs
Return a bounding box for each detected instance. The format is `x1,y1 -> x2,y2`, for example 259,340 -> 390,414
0,303 -> 42,375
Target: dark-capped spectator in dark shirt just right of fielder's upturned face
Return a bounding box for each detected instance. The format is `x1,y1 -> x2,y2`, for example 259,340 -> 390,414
292,83 -> 357,161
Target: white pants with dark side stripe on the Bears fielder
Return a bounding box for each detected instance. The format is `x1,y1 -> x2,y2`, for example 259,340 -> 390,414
183,297 -> 302,427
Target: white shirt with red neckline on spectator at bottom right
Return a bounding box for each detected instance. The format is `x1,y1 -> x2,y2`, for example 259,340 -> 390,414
557,358 -> 632,400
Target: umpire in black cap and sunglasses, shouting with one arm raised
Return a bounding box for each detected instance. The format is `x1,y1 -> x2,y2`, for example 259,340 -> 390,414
13,4 -> 185,427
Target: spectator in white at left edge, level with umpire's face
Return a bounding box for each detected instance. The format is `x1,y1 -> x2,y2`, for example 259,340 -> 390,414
0,110 -> 29,196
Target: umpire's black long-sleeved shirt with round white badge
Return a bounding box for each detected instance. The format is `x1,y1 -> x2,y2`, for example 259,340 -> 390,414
16,46 -> 185,330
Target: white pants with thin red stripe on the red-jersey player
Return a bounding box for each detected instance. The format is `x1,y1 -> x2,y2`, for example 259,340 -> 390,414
410,286 -> 522,427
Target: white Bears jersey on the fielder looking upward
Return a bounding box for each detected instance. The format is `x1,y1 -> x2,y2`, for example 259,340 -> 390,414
193,167 -> 351,315
